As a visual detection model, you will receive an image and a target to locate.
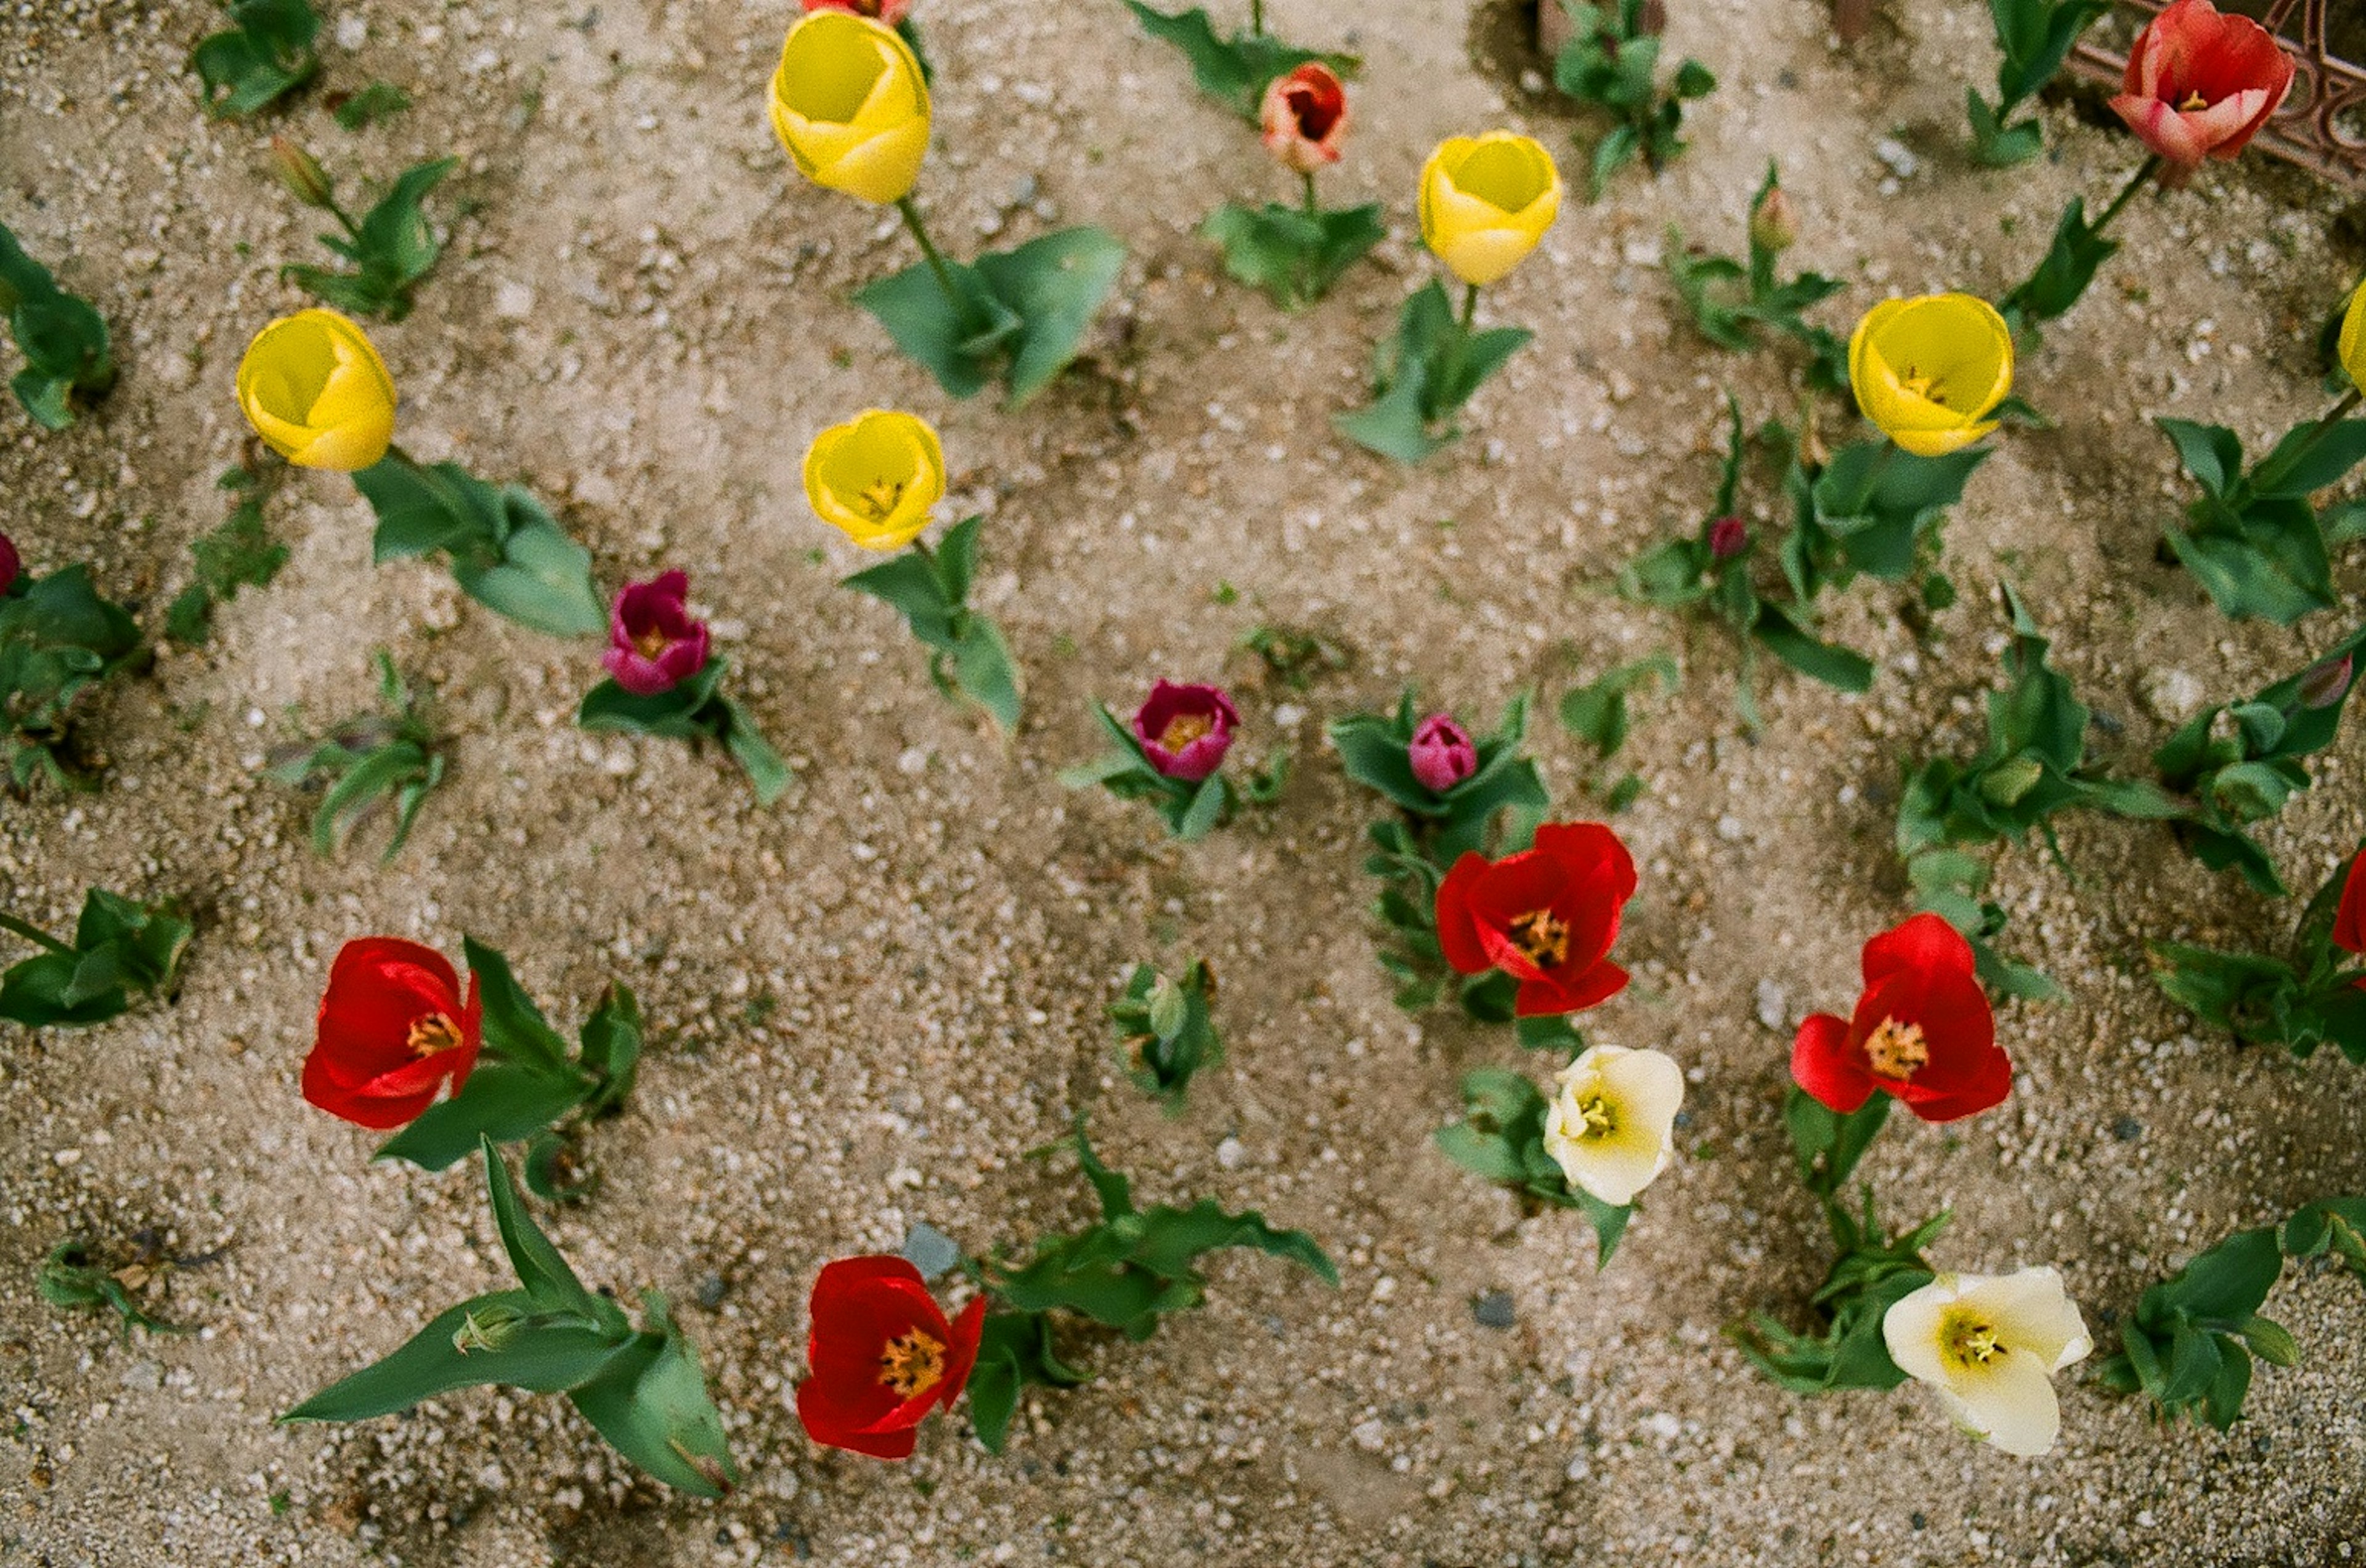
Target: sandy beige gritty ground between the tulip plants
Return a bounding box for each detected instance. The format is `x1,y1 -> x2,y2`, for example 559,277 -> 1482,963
0,0 -> 2366,1568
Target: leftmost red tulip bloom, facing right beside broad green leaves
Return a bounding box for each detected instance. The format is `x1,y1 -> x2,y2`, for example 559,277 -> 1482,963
303,936 -> 485,1133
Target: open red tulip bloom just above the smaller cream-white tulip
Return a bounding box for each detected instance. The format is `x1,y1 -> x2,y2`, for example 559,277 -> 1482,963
1436,823 -> 1635,1017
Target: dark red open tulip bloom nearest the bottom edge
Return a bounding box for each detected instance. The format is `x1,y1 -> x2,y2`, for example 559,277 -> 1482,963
797,1256 -> 986,1459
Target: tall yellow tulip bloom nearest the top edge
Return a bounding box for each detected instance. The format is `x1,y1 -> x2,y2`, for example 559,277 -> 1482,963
771,12 -> 927,206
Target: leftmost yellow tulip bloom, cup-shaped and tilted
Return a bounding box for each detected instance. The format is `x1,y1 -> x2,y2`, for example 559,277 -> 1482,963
239,310 -> 395,473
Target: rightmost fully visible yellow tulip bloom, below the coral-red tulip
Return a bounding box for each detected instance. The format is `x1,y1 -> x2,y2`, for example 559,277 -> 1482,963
1848,293 -> 2014,457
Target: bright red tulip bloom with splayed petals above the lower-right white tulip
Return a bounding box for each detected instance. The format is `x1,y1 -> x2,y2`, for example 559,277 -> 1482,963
1791,916 -> 2014,1121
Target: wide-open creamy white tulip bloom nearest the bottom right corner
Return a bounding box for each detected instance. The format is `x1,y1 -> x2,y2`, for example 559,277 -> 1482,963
1881,1267 -> 2094,1457
